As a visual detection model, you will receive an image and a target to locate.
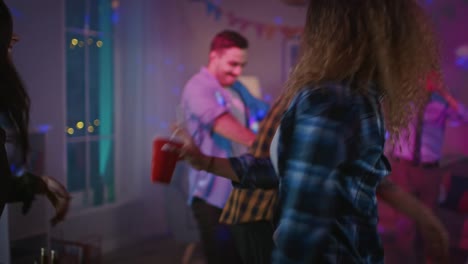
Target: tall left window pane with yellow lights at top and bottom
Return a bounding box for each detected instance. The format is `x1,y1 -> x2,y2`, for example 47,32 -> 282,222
66,33 -> 86,137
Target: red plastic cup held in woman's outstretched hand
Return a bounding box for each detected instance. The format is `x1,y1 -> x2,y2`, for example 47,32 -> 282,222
151,138 -> 183,184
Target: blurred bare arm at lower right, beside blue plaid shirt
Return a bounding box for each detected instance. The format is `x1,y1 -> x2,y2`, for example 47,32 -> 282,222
377,178 -> 449,263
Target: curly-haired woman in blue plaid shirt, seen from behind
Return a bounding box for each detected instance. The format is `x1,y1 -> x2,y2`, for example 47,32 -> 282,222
171,0 -> 446,263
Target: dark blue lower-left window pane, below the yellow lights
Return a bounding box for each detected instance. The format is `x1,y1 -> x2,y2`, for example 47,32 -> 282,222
67,142 -> 86,192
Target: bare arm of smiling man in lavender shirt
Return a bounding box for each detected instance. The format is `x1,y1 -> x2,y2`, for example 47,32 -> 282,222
213,112 -> 255,147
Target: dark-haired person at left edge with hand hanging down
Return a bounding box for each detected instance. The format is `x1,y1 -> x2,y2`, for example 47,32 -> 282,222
0,1 -> 70,225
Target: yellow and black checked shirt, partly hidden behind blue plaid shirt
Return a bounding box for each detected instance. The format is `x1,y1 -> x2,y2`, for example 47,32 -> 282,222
220,100 -> 285,224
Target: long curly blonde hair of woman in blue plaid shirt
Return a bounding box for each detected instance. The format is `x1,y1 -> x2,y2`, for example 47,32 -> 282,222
283,0 -> 442,141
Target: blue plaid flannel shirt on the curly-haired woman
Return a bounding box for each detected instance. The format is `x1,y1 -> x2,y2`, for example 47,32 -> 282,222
231,84 -> 390,263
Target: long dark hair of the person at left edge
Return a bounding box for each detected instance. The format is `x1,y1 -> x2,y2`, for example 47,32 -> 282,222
0,0 -> 30,162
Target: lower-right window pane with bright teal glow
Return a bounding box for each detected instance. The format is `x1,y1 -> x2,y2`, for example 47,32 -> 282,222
90,139 -> 115,206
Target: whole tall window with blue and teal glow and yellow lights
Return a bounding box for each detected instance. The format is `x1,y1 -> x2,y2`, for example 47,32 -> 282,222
66,0 -> 115,206
